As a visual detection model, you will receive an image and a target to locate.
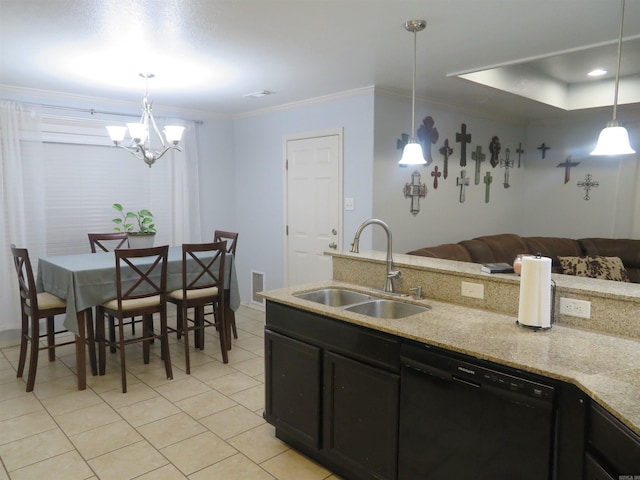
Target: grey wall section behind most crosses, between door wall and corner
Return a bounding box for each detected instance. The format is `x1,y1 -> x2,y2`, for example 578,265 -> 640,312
373,93 -> 530,252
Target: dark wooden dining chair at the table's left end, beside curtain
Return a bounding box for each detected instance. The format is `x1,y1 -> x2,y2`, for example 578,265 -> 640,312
11,244 -> 79,392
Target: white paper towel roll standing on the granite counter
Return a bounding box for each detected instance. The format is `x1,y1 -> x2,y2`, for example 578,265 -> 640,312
518,256 -> 551,328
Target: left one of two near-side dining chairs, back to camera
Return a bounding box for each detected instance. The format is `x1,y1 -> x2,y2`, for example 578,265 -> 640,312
96,245 -> 173,393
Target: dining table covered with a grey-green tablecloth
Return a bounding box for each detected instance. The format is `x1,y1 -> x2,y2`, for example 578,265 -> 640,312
36,246 -> 240,390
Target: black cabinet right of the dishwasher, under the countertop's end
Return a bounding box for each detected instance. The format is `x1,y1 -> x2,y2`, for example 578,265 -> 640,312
584,402 -> 640,480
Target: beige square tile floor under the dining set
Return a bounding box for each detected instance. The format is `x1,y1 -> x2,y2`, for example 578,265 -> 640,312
0,306 -> 338,480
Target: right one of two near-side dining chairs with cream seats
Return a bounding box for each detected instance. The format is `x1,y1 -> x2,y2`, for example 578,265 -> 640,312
167,241 -> 229,374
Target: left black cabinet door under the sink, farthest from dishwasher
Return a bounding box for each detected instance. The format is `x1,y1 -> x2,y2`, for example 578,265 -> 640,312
265,330 -> 322,449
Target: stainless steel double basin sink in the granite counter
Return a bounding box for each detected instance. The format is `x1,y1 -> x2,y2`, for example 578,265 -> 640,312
294,288 -> 429,318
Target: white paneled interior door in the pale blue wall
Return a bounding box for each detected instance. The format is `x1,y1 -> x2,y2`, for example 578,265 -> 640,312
286,133 -> 342,285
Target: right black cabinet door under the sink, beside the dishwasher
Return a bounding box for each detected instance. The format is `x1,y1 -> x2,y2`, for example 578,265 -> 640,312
322,352 -> 400,479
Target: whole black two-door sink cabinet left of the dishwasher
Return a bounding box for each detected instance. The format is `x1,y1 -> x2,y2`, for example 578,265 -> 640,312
265,302 -> 400,480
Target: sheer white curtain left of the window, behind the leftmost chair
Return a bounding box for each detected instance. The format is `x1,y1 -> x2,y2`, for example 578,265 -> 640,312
0,101 -> 46,331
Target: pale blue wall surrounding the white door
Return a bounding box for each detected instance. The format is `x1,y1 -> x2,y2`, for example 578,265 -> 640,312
233,90 -> 374,301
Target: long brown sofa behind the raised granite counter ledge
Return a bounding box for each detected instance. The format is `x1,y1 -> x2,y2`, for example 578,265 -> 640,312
407,233 -> 640,283
